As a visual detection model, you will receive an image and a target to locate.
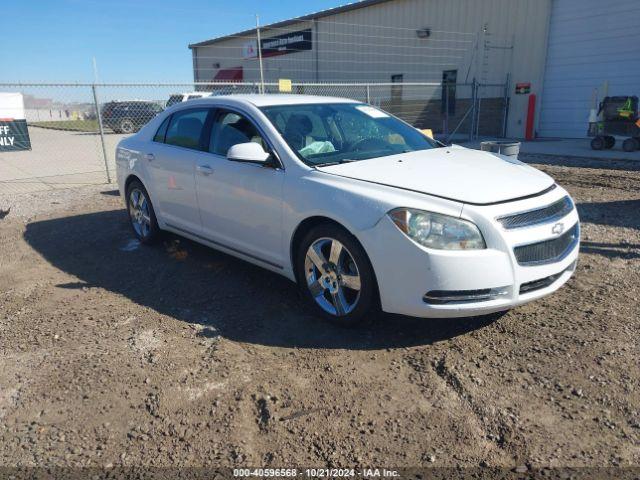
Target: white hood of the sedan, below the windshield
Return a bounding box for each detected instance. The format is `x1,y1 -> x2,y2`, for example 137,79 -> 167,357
318,146 -> 554,205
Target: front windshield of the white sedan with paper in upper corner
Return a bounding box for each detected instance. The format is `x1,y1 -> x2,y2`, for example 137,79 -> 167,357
261,103 -> 439,166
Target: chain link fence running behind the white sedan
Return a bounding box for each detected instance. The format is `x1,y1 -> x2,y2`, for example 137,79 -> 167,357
0,82 -> 508,194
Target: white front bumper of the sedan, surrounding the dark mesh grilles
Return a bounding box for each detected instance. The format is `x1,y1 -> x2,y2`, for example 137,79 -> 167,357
363,188 -> 579,318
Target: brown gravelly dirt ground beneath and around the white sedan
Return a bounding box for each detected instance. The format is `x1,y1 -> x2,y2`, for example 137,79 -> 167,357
0,157 -> 640,469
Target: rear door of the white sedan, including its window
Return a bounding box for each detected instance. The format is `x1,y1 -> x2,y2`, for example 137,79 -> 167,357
145,108 -> 210,234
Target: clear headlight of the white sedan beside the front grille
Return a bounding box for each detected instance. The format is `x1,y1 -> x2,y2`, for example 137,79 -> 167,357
388,208 -> 487,250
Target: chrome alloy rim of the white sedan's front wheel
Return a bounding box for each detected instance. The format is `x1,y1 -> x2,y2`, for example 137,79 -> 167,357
304,238 -> 361,317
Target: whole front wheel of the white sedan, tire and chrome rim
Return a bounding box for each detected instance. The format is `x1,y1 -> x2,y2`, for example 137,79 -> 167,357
295,224 -> 379,327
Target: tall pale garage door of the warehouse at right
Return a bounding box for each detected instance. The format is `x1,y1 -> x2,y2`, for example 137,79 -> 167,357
538,0 -> 640,138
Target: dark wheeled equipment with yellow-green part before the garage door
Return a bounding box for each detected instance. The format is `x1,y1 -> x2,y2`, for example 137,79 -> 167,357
589,96 -> 640,152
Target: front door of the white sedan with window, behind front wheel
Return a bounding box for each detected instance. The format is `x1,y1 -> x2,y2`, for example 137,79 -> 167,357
196,109 -> 284,267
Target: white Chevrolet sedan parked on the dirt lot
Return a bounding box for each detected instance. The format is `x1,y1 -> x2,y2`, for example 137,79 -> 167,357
116,95 -> 580,325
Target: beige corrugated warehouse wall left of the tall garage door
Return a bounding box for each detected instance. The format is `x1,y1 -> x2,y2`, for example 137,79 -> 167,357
194,0 -> 551,137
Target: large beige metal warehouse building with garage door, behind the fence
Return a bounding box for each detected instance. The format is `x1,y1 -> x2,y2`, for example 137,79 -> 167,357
189,0 -> 640,138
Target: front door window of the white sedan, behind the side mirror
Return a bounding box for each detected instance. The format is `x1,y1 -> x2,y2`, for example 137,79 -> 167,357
209,110 -> 268,156
